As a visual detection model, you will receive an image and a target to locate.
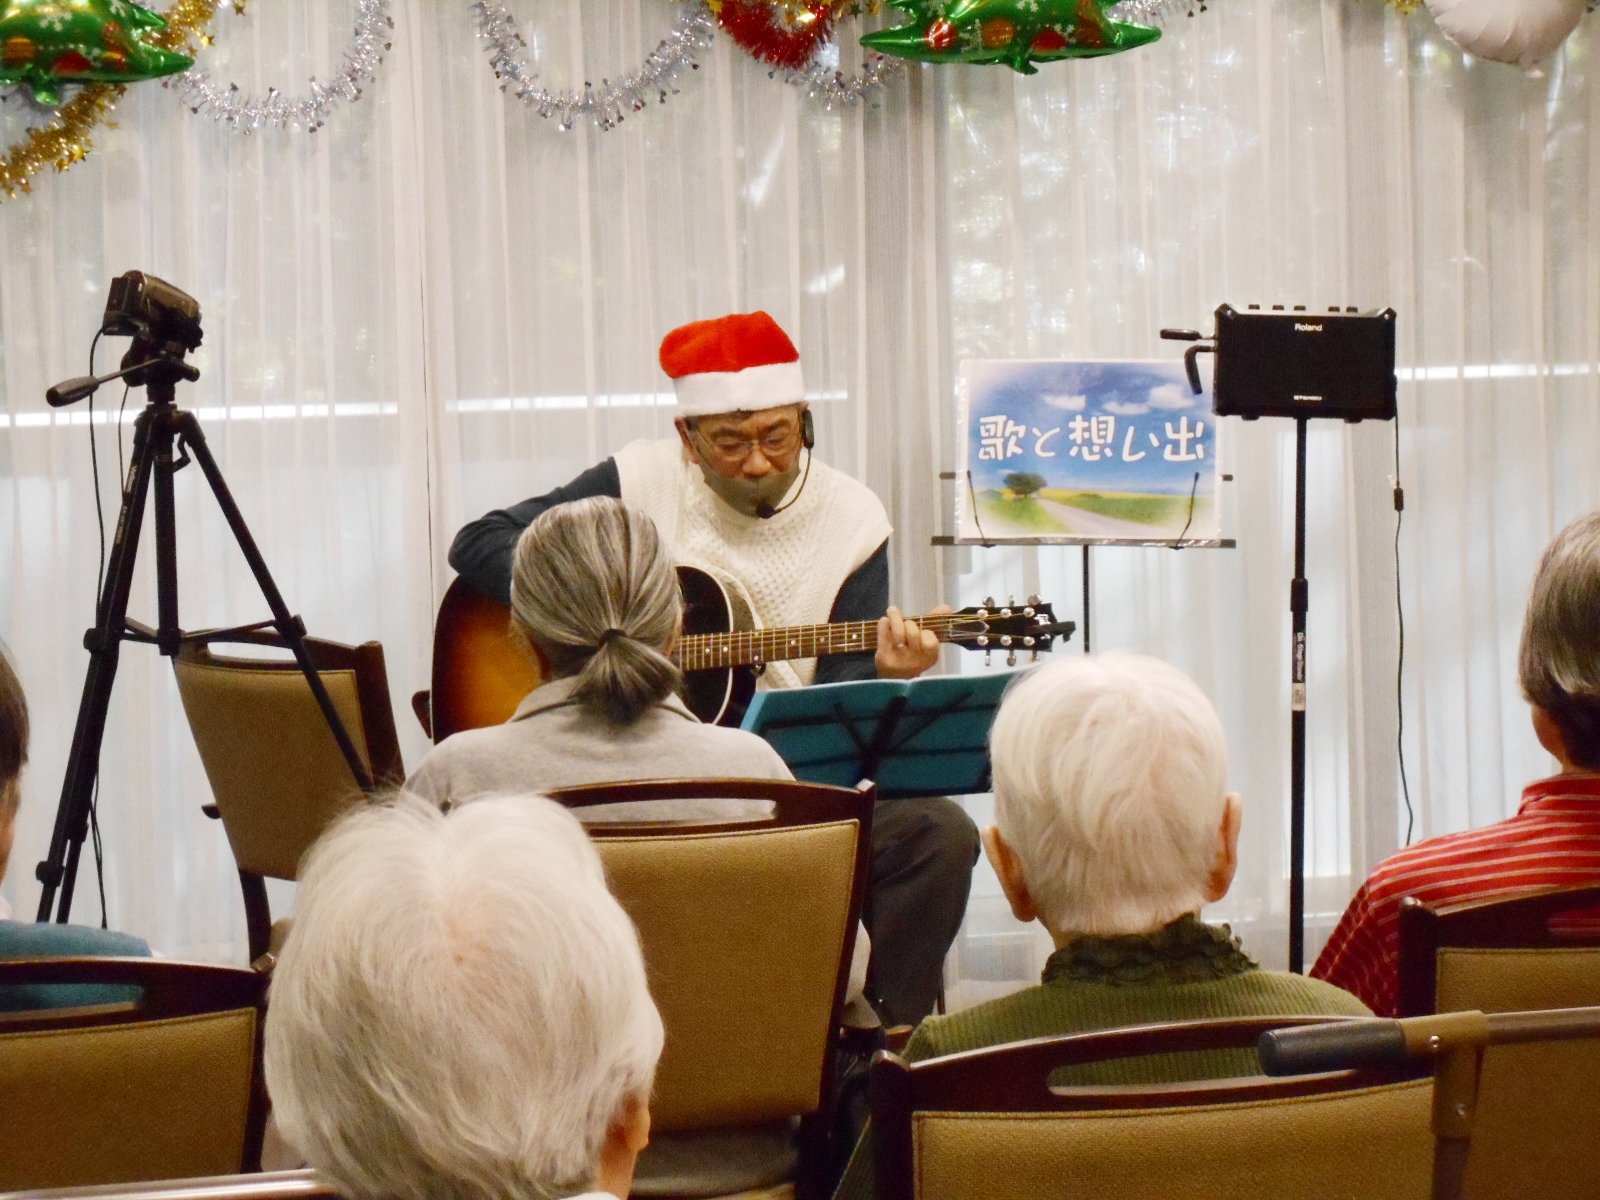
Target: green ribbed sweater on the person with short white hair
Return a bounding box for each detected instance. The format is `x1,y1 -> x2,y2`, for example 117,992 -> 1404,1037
835,917 -> 1371,1200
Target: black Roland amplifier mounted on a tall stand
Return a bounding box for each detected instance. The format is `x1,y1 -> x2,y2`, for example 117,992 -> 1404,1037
1211,304 -> 1395,421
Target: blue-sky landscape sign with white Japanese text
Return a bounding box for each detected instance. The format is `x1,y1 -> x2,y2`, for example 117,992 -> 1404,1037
955,358 -> 1219,544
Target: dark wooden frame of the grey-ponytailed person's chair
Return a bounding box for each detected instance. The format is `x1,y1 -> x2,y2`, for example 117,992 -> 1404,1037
549,779 -> 877,1200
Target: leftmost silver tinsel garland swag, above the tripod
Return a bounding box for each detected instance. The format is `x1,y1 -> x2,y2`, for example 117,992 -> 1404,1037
168,0 -> 395,134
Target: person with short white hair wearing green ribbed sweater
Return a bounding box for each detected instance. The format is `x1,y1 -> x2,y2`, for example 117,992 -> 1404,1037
840,653 -> 1366,1197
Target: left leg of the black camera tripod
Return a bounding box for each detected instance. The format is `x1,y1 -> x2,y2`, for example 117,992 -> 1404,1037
35,410 -> 171,923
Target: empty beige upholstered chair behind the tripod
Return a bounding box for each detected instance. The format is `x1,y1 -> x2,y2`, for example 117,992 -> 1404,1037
173,638 -> 405,960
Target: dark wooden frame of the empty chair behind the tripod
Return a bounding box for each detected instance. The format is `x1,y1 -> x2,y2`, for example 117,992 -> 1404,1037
178,630 -> 405,962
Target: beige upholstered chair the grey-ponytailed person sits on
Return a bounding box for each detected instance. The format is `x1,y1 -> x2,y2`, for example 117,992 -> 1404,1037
552,779 -> 874,1197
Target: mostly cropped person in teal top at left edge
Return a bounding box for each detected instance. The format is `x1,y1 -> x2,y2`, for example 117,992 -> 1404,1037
0,651 -> 150,1013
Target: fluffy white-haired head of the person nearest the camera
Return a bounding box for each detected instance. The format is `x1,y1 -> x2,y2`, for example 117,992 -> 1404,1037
266,794 -> 662,1200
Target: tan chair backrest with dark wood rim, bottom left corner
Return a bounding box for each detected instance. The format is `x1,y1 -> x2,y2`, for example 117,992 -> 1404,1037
0,958 -> 267,1190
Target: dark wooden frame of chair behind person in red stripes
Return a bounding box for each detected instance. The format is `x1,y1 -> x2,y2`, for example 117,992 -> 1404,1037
1398,883 -> 1600,1016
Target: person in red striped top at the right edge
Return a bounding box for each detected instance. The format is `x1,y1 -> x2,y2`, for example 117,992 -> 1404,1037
1312,512 -> 1600,1016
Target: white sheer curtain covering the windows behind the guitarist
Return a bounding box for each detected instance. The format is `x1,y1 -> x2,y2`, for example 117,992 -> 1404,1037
0,0 -> 1600,998
